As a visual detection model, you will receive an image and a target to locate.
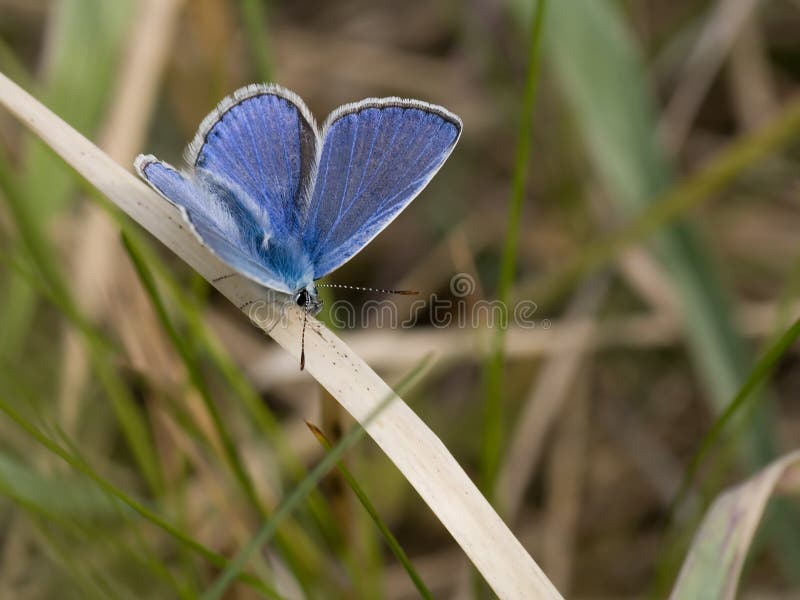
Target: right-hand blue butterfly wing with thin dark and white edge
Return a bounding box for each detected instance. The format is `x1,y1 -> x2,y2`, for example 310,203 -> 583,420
302,98 -> 461,279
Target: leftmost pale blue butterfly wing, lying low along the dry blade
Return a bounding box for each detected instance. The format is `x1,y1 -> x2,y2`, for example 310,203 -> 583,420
136,156 -> 293,293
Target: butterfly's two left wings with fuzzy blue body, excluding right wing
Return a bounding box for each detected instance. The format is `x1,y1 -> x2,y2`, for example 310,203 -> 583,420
136,85 -> 318,293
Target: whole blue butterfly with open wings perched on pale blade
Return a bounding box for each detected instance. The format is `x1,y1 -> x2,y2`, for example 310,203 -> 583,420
135,84 -> 462,366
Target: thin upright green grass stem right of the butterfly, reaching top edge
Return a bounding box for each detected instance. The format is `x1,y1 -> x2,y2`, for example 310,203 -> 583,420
481,0 -> 547,498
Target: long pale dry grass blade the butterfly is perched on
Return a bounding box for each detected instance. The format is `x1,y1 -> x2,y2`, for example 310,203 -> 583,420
0,75 -> 561,598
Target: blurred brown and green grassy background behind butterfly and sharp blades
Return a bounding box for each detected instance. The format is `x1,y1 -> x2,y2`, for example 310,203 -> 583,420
0,0 -> 800,598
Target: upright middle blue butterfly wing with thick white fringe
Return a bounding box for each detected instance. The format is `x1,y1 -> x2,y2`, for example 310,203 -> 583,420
186,85 -> 318,239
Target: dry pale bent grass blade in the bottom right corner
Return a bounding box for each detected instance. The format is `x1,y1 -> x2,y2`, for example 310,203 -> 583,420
670,450 -> 800,600
